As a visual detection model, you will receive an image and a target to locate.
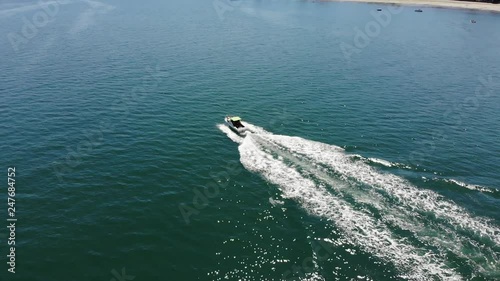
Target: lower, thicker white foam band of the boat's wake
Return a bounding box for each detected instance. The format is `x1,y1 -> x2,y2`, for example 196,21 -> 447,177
239,135 -> 461,280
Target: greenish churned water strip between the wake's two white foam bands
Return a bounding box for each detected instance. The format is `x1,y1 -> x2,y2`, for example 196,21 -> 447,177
254,132 -> 500,276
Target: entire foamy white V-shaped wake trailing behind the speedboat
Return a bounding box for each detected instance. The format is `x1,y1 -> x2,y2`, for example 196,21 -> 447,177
218,123 -> 500,280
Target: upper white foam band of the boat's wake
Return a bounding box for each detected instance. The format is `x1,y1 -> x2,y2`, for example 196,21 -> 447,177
261,134 -> 500,245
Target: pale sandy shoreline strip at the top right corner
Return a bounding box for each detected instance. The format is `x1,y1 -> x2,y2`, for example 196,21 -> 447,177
317,0 -> 500,13
